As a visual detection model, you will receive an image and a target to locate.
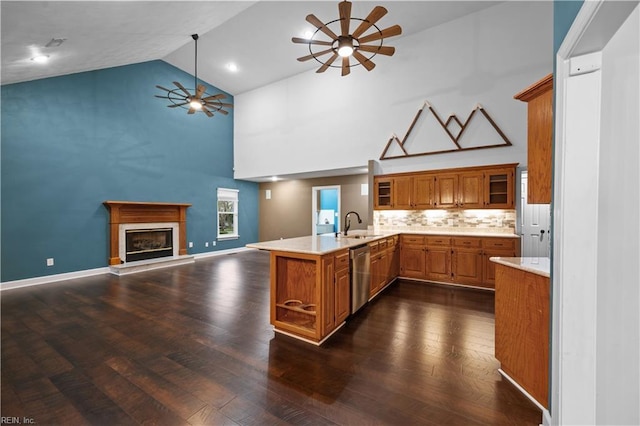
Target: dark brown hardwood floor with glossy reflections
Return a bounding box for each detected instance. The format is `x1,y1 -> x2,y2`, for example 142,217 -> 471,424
1,251 -> 541,425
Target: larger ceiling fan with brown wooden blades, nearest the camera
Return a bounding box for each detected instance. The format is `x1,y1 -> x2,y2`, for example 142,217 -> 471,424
291,0 -> 402,76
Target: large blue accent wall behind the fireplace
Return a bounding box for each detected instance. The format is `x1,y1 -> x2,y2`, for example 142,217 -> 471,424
0,61 -> 258,282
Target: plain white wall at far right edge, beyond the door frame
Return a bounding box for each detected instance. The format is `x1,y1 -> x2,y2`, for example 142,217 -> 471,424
595,7 -> 640,424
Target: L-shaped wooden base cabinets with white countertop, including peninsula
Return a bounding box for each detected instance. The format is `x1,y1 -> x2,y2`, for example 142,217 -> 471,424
247,230 -> 520,345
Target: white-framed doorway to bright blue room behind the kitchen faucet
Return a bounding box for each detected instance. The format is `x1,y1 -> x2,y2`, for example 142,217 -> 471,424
311,185 -> 340,235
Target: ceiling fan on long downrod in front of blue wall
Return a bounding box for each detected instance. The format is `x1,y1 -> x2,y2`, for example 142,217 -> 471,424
155,34 -> 233,117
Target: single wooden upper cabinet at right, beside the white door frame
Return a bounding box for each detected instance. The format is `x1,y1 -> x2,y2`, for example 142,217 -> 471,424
514,74 -> 553,204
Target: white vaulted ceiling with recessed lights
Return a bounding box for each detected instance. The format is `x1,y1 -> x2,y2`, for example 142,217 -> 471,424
0,0 -> 500,95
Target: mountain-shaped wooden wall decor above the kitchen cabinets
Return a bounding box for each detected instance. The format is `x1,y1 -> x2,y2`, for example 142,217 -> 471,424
380,101 -> 511,160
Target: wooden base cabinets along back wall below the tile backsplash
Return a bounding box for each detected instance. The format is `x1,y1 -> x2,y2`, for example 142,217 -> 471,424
400,234 -> 520,288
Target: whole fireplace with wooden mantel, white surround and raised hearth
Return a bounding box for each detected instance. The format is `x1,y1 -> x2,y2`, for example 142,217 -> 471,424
103,201 -> 193,275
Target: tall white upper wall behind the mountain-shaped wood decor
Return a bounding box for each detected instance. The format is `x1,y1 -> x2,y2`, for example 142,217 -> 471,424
234,2 -> 553,179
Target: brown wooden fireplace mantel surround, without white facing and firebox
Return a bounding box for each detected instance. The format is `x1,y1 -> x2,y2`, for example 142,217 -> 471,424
102,201 -> 191,265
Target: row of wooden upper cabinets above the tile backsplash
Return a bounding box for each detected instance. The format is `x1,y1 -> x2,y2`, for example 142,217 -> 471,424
374,164 -> 516,210
